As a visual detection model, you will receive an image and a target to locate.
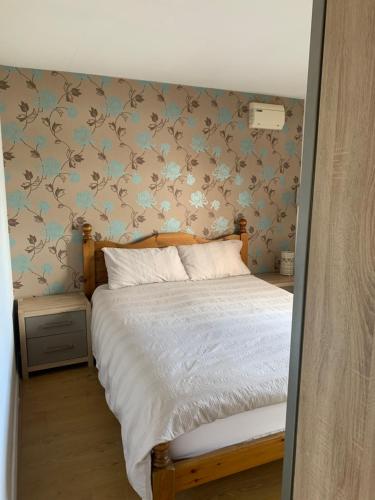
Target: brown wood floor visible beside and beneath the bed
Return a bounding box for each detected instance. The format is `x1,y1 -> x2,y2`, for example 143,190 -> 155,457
19,367 -> 281,500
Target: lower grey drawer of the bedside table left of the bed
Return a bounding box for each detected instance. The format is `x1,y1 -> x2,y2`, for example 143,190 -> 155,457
27,331 -> 87,366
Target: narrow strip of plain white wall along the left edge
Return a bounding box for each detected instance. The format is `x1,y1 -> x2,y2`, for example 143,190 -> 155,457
0,122 -> 18,500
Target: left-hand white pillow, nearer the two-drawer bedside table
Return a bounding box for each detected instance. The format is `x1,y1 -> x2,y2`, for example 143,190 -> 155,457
103,247 -> 189,290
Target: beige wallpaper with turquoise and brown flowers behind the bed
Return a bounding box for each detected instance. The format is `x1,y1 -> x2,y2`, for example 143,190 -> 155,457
0,66 -> 303,297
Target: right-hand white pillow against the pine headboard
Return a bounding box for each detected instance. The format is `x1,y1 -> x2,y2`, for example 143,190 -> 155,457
177,240 -> 250,280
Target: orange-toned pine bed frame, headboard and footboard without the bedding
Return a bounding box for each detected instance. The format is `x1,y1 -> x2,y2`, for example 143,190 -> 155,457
82,219 -> 284,500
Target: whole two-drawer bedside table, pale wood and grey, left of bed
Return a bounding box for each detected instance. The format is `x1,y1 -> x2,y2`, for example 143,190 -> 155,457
18,292 -> 93,379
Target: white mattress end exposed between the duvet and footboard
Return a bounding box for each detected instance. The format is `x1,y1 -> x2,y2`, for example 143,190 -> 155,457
169,403 -> 286,460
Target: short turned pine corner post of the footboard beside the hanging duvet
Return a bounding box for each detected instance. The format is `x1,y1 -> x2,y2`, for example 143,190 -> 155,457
152,443 -> 175,500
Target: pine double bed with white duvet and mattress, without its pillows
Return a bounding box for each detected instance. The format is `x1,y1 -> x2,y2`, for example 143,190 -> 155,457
83,220 -> 292,500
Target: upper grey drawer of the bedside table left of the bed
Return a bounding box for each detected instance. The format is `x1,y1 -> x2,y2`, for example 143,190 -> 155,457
25,311 -> 86,339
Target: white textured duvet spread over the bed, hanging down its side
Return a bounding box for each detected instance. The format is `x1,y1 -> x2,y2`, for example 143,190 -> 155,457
92,276 -> 293,500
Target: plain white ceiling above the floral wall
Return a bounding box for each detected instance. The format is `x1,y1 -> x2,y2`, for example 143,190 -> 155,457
0,0 -> 312,97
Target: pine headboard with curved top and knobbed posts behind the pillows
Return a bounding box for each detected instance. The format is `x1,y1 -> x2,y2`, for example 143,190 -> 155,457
82,219 -> 249,298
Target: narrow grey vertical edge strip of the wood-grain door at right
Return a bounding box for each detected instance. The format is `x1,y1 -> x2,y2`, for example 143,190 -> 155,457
282,0 -> 326,500
